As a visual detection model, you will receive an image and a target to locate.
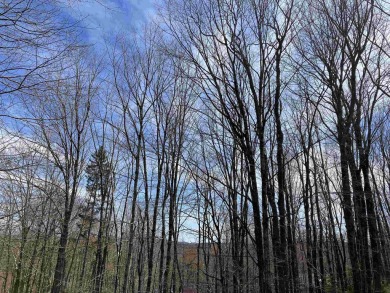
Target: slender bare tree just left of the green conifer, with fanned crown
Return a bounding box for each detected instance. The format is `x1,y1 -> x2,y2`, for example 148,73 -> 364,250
21,55 -> 99,293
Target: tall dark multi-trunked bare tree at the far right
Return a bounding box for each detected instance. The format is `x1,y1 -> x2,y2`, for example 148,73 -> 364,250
298,1 -> 387,292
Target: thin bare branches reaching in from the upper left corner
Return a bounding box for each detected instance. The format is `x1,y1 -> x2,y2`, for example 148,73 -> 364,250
0,0 -> 75,95
